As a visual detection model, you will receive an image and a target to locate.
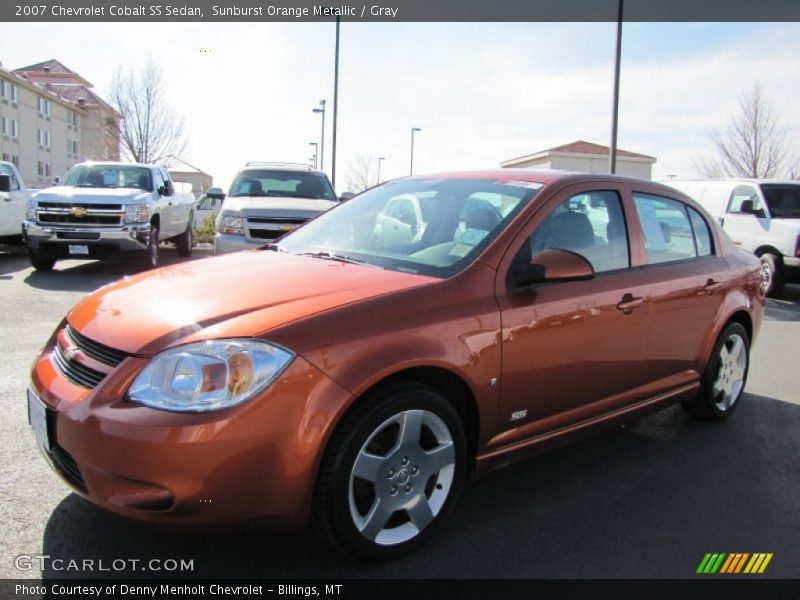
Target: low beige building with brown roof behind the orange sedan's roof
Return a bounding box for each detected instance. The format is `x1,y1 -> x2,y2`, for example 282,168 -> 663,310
500,140 -> 656,179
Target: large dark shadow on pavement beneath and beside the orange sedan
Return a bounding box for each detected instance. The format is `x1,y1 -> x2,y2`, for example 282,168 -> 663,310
42,394 -> 800,579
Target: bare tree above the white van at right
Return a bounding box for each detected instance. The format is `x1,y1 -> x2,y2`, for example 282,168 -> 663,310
695,82 -> 797,178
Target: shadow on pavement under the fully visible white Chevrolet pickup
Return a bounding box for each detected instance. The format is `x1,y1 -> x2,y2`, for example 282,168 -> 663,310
25,246 -> 211,292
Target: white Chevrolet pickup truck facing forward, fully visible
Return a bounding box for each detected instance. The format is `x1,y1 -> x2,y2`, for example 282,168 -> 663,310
22,162 -> 195,270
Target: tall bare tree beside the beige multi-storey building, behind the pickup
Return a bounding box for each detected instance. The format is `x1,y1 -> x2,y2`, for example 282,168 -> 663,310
110,57 -> 187,164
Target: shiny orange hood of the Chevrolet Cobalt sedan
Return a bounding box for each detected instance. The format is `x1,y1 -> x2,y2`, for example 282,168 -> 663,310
67,250 -> 439,356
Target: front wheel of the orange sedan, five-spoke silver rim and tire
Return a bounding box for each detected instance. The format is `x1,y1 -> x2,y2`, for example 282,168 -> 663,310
314,382 -> 467,560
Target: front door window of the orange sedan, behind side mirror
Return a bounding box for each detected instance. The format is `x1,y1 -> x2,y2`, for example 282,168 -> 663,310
521,190 -> 631,273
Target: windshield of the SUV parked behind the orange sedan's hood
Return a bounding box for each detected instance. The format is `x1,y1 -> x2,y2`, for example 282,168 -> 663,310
230,169 -> 336,201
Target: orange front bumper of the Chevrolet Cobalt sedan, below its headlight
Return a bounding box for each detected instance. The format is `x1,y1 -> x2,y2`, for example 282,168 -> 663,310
31,340 -> 351,530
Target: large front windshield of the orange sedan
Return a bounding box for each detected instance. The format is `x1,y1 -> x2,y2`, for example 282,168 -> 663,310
272,179 -> 542,277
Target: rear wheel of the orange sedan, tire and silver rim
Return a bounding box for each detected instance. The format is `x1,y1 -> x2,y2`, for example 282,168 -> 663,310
683,323 -> 750,421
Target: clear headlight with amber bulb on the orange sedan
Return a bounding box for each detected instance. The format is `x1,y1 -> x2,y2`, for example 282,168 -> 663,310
128,339 -> 294,412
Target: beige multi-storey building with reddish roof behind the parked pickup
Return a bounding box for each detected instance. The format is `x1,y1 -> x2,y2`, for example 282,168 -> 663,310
0,60 -> 121,188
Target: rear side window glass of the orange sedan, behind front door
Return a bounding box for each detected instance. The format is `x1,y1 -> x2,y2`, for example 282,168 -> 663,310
633,192 -> 711,265
